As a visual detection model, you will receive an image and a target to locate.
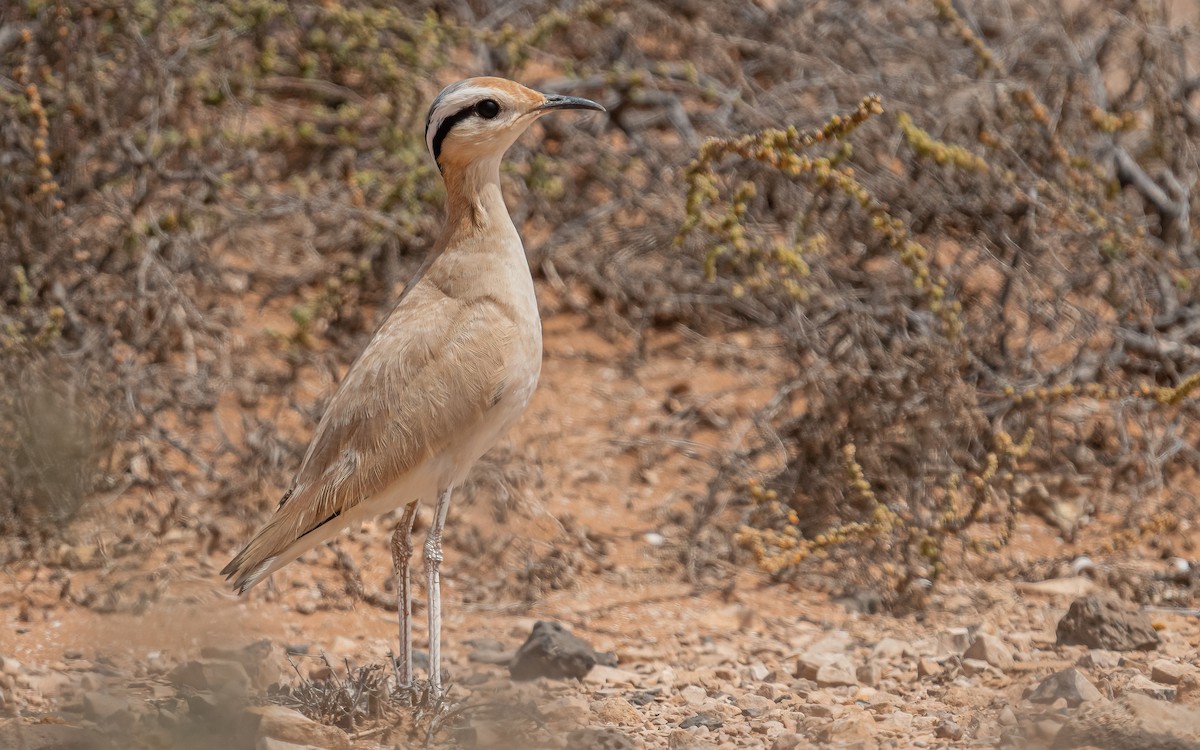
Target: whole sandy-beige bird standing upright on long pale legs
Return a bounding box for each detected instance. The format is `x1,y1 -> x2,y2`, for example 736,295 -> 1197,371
221,78 -> 604,690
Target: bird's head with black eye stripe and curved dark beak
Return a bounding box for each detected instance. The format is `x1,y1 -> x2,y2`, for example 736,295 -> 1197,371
425,78 -> 605,173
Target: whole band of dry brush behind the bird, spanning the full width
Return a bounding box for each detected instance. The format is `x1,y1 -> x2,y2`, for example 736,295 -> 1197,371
0,0 -> 1200,609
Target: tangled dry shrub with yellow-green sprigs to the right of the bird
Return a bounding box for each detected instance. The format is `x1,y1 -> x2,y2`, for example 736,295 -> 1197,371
682,1 -> 1200,594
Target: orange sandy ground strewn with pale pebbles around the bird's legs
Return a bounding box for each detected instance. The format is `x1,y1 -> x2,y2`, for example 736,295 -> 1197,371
0,306 -> 1200,750
